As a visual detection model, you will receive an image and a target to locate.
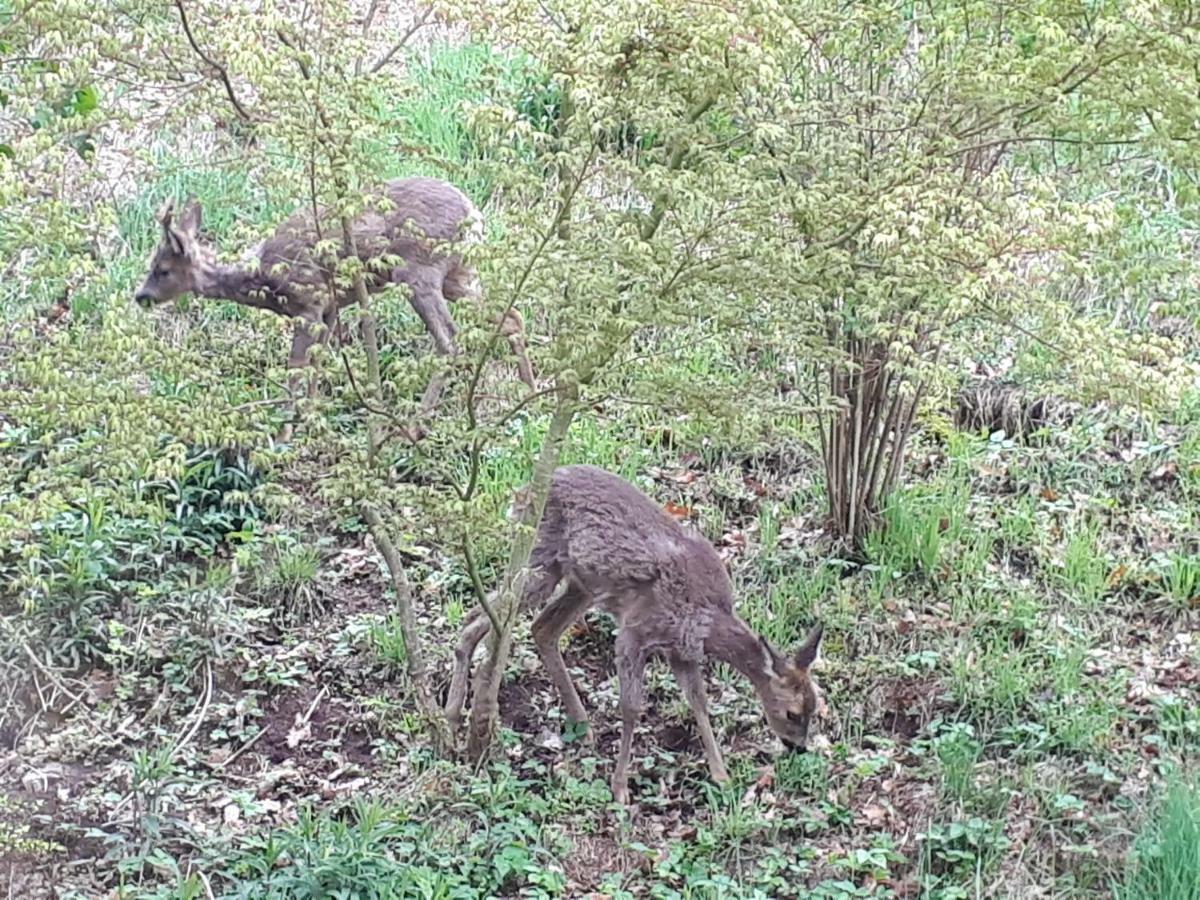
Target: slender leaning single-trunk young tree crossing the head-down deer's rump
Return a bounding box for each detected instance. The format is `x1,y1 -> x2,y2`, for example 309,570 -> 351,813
432,0 -> 777,757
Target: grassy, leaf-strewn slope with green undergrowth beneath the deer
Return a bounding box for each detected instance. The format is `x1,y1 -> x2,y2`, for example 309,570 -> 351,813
0,44 -> 1200,898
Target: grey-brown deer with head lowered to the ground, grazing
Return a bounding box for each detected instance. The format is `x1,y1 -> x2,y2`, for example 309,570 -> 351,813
446,466 -> 822,803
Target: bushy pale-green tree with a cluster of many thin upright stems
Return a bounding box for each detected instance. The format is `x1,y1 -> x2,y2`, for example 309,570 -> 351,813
736,2 -> 1198,545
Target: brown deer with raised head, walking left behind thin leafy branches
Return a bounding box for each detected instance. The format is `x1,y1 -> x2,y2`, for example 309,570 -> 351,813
134,178 -> 535,427
